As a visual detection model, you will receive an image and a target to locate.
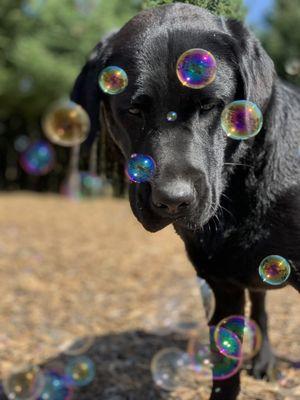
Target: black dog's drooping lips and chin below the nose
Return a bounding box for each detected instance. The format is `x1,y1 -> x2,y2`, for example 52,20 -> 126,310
129,183 -> 214,232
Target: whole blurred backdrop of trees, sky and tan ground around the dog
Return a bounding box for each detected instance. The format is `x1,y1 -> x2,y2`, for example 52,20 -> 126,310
0,0 -> 300,400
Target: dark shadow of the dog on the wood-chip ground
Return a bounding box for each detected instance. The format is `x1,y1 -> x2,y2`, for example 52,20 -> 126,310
42,331 -> 187,400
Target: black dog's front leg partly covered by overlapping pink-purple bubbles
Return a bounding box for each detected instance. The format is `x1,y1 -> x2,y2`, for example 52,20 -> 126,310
209,282 -> 245,400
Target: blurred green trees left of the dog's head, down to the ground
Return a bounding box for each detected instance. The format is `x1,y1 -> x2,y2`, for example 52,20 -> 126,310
0,0 -> 141,190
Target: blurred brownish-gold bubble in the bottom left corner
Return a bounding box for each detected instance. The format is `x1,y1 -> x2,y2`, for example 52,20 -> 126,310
3,366 -> 45,400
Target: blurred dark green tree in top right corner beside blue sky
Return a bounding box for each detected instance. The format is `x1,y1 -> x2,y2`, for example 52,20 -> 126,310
262,0 -> 300,85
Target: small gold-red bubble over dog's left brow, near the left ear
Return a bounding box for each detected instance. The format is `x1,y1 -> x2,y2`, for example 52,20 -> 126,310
99,66 -> 128,95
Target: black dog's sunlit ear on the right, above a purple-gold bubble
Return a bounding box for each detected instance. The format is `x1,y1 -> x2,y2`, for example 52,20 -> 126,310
226,20 -> 275,111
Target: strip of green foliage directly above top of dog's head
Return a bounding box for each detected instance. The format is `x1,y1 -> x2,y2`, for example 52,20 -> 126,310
143,0 -> 245,20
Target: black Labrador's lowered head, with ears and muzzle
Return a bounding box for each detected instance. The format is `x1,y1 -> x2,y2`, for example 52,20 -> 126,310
72,3 -> 274,231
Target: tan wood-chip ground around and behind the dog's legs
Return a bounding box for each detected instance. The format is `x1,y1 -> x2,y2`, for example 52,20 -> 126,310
0,193 -> 300,400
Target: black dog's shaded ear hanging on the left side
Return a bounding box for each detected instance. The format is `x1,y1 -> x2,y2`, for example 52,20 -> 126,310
70,35 -> 126,196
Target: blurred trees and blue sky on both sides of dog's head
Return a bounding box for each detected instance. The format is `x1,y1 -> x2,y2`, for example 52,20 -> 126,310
0,0 -> 300,193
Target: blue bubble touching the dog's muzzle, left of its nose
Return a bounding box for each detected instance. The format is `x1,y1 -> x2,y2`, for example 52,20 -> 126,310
126,154 -> 155,183
